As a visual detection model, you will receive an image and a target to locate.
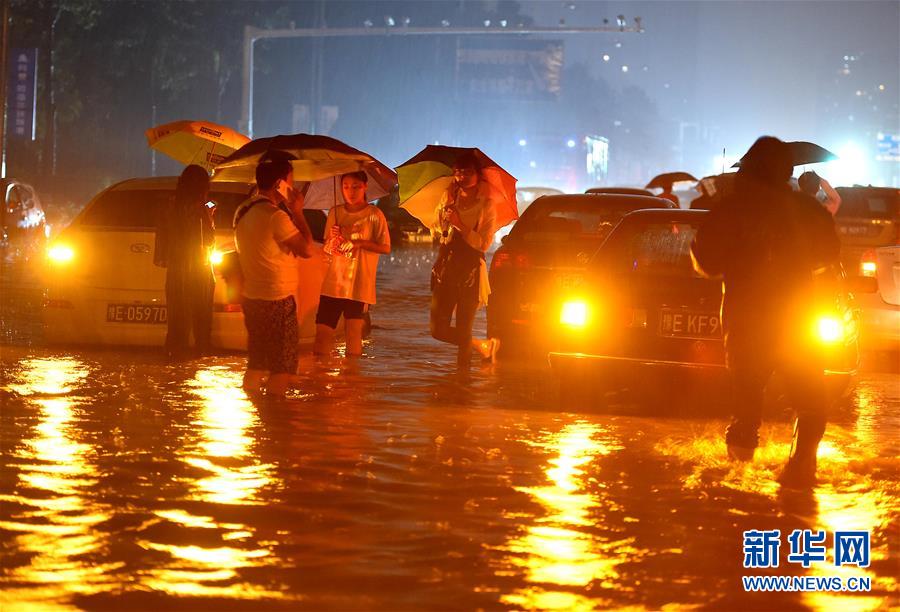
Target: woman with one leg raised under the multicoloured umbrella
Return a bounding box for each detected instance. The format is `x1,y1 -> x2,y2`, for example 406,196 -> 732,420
431,154 -> 500,365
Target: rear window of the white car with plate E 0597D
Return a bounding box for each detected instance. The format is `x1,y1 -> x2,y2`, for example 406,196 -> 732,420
80,189 -> 246,229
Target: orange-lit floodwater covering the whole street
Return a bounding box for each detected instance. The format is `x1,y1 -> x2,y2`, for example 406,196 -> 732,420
0,248 -> 900,611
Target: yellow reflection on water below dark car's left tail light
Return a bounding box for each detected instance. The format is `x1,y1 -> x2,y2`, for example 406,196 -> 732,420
501,422 -> 633,609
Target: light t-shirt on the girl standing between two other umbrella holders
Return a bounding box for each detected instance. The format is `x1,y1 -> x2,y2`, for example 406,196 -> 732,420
322,205 -> 391,304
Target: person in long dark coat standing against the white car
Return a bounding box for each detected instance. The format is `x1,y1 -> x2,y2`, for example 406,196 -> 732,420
154,165 -> 215,359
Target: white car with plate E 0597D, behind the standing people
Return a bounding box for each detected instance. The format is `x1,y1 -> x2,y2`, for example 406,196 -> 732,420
43,177 -> 326,350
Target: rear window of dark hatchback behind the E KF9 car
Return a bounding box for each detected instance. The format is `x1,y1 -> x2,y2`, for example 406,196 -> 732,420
510,200 -> 648,242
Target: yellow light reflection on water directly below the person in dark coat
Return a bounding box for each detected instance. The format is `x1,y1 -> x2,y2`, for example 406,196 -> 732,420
140,367 -> 286,600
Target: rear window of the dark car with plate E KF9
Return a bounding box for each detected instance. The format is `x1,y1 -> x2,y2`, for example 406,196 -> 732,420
599,222 -> 701,278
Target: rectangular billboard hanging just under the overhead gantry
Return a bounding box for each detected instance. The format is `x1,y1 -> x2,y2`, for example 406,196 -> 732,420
456,38 -> 563,101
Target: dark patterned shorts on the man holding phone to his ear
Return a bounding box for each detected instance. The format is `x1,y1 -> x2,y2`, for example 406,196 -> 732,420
243,295 -> 300,374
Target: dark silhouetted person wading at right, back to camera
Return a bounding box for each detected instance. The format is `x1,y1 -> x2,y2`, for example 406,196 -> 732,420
691,136 -> 840,486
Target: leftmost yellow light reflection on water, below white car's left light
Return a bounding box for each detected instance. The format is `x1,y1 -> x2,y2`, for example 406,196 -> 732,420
0,359 -> 123,609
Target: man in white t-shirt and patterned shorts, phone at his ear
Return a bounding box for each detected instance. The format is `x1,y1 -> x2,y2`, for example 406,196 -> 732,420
234,159 -> 312,395
